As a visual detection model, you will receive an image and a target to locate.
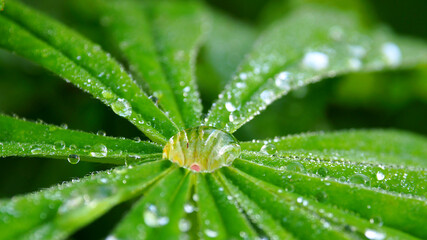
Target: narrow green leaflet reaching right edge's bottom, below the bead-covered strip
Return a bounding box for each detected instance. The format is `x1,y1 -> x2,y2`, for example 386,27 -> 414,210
236,160 -> 427,238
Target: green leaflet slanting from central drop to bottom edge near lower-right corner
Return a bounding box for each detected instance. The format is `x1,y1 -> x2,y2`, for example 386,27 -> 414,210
222,167 -> 416,239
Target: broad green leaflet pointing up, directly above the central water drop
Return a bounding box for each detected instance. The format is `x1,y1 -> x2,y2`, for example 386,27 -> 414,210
93,0 -> 206,129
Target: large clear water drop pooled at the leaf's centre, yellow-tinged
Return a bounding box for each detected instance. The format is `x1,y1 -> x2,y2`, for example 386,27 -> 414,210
163,126 -> 240,172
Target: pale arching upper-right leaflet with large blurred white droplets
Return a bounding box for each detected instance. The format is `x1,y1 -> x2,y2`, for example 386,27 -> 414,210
207,5 -> 427,132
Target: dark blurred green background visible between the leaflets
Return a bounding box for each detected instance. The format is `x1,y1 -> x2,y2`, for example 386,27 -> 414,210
0,0 -> 427,239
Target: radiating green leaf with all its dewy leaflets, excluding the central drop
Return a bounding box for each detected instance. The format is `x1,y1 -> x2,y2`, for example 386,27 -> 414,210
0,0 -> 427,240
